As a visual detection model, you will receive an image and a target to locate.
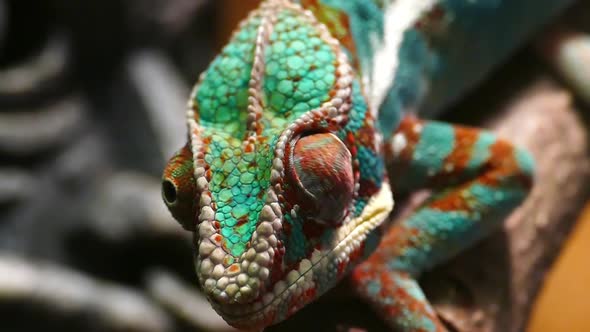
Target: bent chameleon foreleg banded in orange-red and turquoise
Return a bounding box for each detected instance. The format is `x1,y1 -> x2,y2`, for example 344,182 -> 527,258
352,117 -> 533,331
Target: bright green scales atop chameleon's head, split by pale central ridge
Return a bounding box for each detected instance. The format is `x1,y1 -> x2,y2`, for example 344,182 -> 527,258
193,11 -> 336,255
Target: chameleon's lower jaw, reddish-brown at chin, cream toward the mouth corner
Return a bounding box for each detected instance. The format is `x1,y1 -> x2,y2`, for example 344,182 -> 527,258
212,182 -> 394,328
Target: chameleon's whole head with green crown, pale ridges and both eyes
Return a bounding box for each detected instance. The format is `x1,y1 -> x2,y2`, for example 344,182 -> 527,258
162,1 -> 393,328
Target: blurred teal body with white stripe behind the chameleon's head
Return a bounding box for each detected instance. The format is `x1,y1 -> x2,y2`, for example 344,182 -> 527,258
300,0 -> 573,137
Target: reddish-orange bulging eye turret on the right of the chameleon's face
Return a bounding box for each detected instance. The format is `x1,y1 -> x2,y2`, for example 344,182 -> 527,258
289,133 -> 354,226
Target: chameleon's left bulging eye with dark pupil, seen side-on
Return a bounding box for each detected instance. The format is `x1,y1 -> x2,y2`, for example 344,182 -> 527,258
162,146 -> 197,231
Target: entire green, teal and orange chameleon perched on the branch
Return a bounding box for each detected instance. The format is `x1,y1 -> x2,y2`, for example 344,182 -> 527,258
162,0 -> 584,331
